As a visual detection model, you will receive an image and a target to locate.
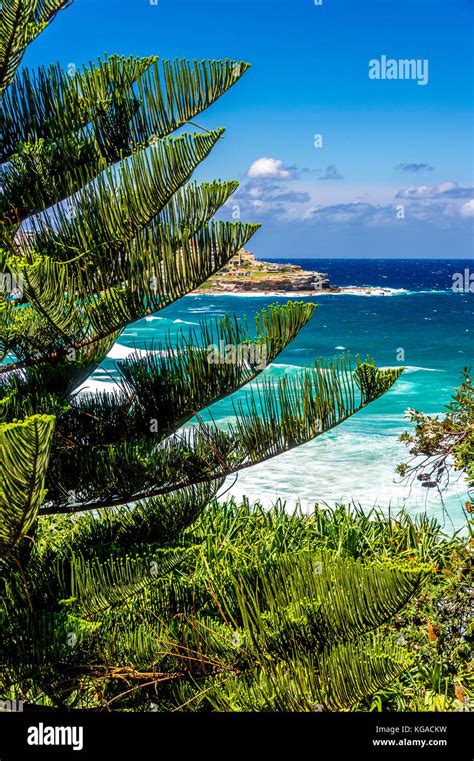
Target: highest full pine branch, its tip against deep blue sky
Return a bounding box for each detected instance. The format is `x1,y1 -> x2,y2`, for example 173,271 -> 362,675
0,56 -> 248,227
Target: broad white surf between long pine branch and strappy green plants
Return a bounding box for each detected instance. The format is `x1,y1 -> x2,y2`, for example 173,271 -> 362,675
223,428 -> 466,526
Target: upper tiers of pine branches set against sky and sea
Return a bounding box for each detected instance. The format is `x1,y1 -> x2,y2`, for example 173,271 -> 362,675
0,0 -> 400,536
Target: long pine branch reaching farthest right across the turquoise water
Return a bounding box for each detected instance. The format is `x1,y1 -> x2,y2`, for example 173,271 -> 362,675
42,357 -> 402,514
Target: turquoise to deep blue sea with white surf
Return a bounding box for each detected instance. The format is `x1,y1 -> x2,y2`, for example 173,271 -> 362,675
89,259 -> 474,530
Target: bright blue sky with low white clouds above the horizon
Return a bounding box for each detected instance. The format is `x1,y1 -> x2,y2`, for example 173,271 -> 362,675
24,0 -> 474,258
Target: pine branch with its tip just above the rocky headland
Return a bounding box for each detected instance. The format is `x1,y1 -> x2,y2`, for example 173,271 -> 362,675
0,222 -> 258,376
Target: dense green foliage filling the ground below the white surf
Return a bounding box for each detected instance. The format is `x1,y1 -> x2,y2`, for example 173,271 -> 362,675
0,494 -> 472,711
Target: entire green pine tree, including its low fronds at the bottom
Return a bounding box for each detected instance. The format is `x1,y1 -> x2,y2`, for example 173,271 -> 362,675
0,0 -> 414,710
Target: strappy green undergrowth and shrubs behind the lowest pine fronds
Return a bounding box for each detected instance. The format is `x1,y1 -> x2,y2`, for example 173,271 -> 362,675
185,499 -> 474,711
